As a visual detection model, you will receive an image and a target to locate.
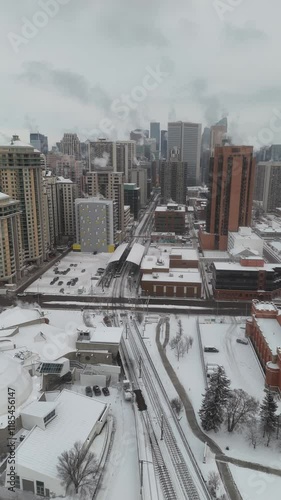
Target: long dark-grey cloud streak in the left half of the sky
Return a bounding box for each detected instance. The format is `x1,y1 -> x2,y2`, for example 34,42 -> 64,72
18,61 -> 112,111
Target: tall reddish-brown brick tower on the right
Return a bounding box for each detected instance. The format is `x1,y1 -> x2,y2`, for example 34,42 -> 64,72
199,146 -> 255,250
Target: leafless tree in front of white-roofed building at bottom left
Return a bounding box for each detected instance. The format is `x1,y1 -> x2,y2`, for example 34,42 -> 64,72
57,442 -> 98,496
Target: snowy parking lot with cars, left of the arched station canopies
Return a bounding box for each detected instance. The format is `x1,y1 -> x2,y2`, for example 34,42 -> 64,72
25,252 -> 111,295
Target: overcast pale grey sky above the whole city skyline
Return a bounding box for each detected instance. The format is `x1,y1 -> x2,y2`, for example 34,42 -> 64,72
0,0 -> 281,146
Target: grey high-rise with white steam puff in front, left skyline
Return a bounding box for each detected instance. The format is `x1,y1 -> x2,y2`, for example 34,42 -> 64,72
88,139 -> 117,172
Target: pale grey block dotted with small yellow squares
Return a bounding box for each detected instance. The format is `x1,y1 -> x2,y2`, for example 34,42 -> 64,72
75,197 -> 117,253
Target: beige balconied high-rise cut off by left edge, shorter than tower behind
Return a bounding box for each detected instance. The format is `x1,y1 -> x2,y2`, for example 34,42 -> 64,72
0,193 -> 24,284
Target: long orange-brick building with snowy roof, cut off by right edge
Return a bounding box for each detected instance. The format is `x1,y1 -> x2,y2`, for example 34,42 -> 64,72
246,300 -> 281,392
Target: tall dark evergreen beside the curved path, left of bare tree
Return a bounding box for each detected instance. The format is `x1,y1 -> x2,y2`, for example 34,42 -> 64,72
199,366 -> 230,432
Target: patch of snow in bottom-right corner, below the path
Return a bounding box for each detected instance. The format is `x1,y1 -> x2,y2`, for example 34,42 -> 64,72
230,465 -> 281,500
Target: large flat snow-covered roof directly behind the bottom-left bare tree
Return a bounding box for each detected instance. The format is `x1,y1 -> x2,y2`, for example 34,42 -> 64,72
16,389 -> 107,478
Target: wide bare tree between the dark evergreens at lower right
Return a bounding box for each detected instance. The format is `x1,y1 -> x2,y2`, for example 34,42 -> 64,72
226,389 -> 259,432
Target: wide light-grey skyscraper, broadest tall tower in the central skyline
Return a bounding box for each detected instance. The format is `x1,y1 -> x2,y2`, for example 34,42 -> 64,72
168,122 -> 201,186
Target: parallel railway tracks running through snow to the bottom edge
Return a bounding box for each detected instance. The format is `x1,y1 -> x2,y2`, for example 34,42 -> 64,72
124,316 -> 210,500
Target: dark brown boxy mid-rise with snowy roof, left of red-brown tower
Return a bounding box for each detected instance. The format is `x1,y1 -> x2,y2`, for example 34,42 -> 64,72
154,202 -> 185,234
